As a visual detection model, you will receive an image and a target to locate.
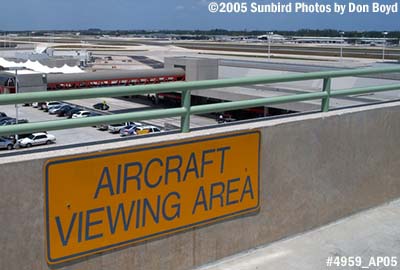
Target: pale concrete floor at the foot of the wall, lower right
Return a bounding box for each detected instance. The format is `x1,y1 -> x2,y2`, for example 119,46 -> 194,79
196,200 -> 400,270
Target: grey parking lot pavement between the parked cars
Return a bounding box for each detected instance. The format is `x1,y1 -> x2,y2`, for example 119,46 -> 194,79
0,98 -> 216,152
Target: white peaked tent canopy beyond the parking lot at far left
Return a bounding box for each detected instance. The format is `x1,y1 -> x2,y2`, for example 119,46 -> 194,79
0,57 -> 83,73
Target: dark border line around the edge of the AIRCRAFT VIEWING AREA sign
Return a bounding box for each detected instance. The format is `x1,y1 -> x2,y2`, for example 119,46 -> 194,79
43,130 -> 261,264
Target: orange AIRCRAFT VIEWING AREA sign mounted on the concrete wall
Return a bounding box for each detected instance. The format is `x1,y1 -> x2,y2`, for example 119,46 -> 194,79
44,132 -> 260,264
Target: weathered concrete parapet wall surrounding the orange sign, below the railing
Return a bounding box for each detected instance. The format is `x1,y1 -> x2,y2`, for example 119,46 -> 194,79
0,102 -> 400,270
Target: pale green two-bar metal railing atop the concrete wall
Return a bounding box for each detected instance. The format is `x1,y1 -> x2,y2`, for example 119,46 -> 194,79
0,67 -> 400,136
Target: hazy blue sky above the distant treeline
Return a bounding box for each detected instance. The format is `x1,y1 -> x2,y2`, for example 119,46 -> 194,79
0,0 -> 400,31
